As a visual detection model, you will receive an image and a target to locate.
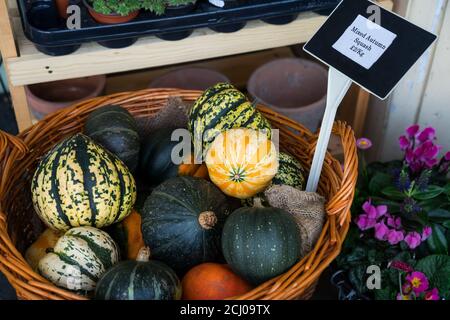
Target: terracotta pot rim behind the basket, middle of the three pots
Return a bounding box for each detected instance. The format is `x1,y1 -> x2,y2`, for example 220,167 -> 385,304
149,67 -> 230,90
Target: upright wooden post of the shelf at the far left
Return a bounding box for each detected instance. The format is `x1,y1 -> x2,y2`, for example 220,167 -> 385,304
0,1 -> 31,131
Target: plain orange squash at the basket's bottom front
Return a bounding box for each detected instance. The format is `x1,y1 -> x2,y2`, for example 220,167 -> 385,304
181,262 -> 252,300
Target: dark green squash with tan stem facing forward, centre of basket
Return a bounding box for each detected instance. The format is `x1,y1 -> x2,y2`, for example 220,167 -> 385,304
142,176 -> 231,274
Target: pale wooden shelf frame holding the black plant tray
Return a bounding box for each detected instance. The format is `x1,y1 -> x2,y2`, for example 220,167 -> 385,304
0,0 -> 393,130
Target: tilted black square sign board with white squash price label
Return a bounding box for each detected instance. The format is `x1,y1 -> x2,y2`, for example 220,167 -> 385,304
304,0 -> 437,99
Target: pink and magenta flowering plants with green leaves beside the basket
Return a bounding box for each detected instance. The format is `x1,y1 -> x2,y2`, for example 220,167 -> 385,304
336,125 -> 450,300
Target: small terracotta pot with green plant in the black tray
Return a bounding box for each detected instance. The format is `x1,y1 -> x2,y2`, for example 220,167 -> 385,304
83,0 -> 144,24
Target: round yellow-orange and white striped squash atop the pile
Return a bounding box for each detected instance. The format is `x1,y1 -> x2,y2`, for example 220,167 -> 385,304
206,128 -> 278,199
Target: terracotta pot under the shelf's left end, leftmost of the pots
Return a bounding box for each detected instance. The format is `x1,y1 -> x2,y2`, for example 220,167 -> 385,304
25,75 -> 106,118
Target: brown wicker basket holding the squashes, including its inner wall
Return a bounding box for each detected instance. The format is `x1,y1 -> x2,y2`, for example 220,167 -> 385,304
0,89 -> 357,300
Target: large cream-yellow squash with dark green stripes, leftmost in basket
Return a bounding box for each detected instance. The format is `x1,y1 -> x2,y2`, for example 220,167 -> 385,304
31,134 -> 136,231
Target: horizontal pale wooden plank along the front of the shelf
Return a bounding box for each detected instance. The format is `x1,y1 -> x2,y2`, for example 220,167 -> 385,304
7,13 -> 325,85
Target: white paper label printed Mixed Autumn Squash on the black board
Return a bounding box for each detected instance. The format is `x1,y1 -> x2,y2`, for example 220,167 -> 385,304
333,15 -> 397,69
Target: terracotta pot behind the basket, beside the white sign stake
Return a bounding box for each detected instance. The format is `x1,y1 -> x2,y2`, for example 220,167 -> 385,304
247,58 -> 328,132
